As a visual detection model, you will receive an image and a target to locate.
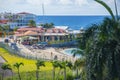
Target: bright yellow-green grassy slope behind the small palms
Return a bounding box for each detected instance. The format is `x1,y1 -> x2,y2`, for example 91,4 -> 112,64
0,48 -> 52,72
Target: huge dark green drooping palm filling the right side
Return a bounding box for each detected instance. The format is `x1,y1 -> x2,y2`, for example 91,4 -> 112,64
76,0 -> 120,80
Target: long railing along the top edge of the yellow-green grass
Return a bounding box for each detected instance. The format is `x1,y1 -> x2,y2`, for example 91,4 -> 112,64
0,42 -> 74,62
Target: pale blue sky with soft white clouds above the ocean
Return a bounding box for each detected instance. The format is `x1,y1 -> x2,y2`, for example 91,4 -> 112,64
0,0 -> 120,15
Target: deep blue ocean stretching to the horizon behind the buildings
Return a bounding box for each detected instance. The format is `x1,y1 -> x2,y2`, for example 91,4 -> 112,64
36,16 -> 108,30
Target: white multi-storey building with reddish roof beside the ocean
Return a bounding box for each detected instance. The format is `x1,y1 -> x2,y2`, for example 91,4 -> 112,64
0,12 -> 36,28
